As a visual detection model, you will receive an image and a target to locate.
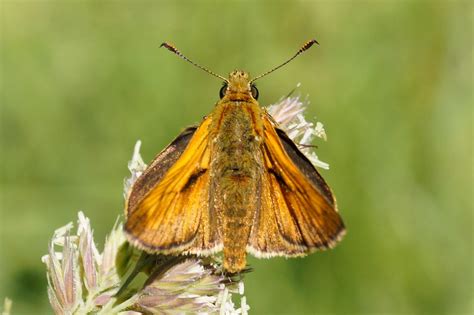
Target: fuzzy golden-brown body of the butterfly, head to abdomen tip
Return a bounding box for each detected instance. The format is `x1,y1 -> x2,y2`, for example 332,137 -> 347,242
210,78 -> 263,272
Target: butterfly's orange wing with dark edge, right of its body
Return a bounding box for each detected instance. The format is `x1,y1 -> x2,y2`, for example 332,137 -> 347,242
247,116 -> 345,257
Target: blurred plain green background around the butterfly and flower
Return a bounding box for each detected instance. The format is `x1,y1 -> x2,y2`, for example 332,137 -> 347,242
0,0 -> 474,314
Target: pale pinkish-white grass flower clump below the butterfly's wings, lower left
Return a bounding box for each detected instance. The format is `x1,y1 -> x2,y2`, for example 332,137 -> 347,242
42,212 -> 248,314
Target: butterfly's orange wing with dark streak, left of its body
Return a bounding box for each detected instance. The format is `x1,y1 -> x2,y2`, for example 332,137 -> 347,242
125,118 -> 222,254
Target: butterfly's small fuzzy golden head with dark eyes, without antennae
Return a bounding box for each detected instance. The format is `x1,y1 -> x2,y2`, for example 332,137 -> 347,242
219,70 -> 258,100
